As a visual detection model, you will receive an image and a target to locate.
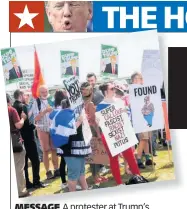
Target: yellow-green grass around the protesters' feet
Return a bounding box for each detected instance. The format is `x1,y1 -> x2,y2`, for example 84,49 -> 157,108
29,145 -> 175,196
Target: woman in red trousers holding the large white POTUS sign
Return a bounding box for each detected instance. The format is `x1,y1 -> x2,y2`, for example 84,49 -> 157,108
96,83 -> 140,185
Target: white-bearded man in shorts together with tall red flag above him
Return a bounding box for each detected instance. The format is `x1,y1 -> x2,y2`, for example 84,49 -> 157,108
32,48 -> 60,179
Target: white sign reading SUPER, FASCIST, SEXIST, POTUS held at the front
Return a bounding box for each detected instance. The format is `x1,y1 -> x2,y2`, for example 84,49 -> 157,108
96,103 -> 138,156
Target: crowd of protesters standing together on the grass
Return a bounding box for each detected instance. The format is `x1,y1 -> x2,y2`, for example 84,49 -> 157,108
7,73 -> 166,197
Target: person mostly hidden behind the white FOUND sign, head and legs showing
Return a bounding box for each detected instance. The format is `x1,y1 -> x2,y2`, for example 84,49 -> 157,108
131,73 -> 153,169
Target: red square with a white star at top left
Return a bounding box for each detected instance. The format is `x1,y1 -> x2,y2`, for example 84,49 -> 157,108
9,1 -> 45,32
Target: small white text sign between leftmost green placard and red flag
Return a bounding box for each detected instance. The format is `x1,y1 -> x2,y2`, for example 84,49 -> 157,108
19,69 -> 34,90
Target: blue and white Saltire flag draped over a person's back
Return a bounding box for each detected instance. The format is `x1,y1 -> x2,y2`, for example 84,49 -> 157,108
49,109 -> 77,147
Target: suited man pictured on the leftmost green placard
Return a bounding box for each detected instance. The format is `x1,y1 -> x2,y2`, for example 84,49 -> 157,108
9,57 -> 23,80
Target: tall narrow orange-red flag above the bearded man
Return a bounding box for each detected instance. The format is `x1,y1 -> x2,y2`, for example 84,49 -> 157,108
32,49 -> 45,99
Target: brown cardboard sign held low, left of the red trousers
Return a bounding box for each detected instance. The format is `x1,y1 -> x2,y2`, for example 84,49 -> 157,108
86,137 -> 110,165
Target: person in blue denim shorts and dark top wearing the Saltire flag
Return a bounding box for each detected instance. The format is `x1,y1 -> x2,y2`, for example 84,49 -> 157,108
57,99 -> 91,192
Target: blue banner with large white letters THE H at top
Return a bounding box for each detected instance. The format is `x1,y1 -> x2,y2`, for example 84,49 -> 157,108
93,1 -> 187,32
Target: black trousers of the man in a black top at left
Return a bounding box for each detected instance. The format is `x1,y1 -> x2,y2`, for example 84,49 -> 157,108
23,133 -> 40,184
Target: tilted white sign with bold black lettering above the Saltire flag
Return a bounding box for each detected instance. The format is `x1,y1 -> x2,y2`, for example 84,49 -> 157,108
63,76 -> 83,118
